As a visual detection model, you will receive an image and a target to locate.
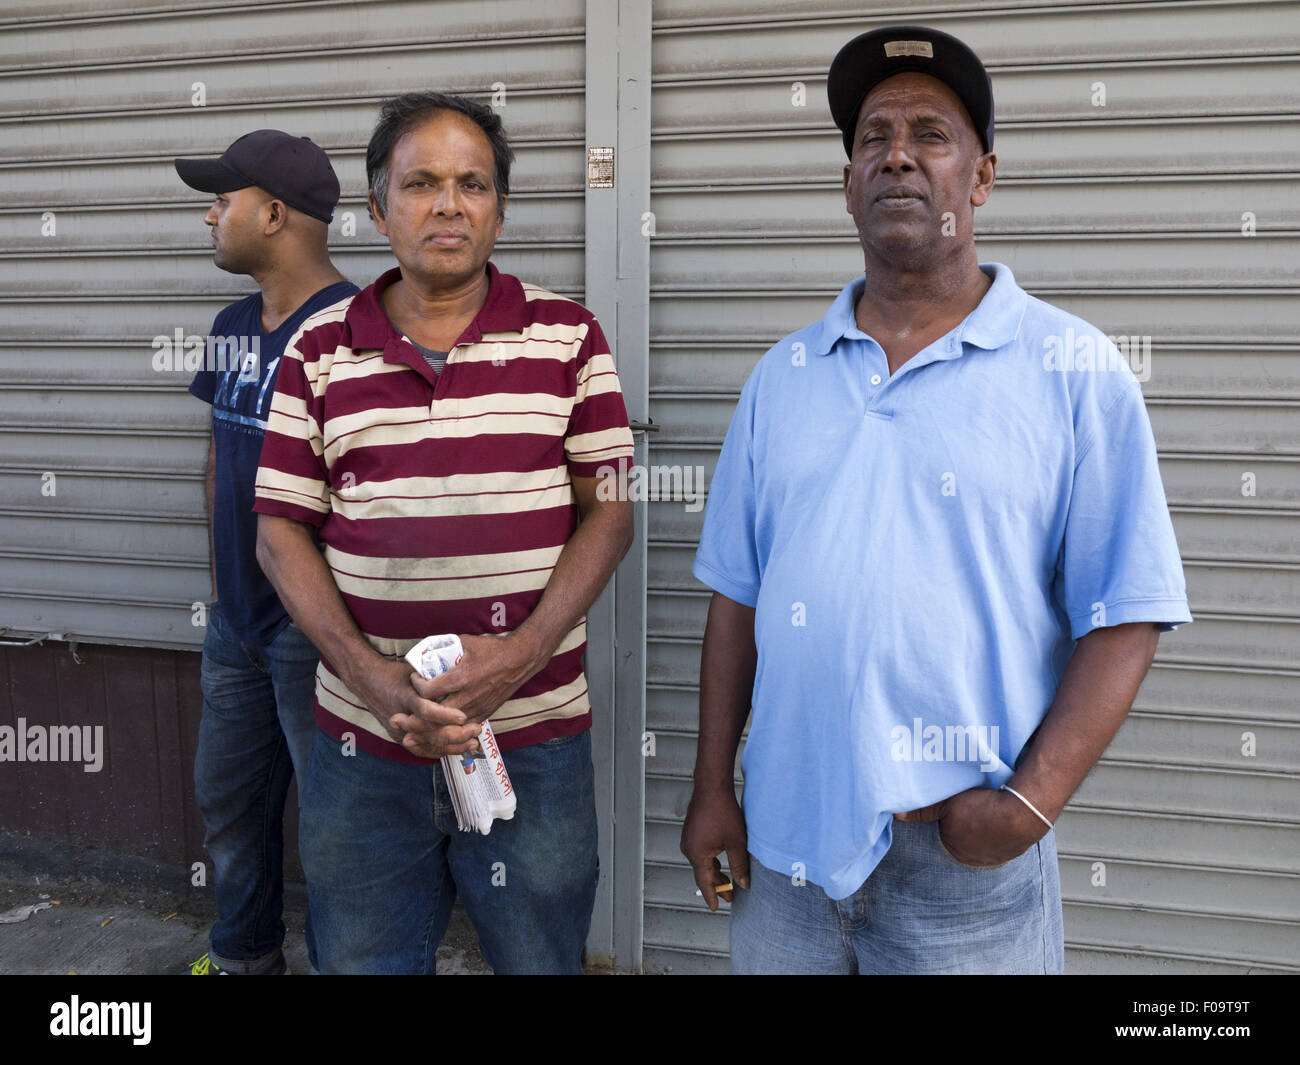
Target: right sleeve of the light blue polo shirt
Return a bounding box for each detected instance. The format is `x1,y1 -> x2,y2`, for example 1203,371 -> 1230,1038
1058,381 -> 1192,640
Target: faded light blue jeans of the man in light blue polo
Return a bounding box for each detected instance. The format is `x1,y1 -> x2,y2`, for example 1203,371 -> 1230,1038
731,821 -> 1065,974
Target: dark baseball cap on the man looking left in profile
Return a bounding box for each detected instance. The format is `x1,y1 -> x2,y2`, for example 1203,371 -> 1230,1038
176,130 -> 339,222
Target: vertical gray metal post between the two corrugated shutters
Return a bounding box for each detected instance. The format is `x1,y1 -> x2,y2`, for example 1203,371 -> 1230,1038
585,0 -> 650,970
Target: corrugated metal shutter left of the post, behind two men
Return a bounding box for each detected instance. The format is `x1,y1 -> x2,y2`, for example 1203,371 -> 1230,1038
0,0 -> 585,648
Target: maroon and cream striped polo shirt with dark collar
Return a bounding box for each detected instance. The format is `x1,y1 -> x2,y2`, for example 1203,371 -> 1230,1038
254,264 -> 632,762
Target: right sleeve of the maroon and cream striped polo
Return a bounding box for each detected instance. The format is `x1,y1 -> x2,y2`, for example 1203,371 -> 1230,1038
564,319 -> 633,477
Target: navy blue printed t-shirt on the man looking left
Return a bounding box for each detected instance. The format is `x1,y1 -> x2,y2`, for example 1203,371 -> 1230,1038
190,281 -> 358,646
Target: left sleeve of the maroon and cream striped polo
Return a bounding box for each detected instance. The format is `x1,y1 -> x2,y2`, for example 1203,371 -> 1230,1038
252,325 -> 330,527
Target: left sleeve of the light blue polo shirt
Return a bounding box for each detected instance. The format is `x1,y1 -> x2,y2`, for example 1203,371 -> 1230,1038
690,376 -> 762,606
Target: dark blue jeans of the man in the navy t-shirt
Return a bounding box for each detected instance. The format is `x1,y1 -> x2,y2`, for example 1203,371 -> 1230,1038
194,603 -> 320,973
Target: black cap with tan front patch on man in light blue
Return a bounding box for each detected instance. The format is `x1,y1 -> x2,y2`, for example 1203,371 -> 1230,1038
826,26 -> 993,159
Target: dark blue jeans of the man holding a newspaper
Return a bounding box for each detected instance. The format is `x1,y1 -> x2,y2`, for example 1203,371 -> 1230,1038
300,730 -> 598,973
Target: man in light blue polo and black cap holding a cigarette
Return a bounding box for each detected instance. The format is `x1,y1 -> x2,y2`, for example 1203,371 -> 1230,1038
683,26 -> 1191,973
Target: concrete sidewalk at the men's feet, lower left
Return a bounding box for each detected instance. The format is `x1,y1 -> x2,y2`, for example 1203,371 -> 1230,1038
0,874 -> 491,975
